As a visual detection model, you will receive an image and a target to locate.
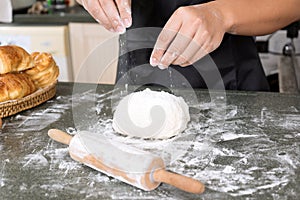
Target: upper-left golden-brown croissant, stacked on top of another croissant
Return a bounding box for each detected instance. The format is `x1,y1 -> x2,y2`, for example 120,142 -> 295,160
0,45 -> 33,74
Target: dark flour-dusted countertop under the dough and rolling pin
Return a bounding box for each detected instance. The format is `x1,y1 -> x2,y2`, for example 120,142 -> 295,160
0,83 -> 300,199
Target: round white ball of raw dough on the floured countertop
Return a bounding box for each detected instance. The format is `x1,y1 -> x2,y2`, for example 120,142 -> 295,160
113,88 -> 190,139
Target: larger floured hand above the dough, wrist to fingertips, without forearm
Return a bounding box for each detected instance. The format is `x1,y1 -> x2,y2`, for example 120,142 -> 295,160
150,4 -> 226,69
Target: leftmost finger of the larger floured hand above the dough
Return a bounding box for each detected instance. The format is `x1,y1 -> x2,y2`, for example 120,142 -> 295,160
150,17 -> 181,67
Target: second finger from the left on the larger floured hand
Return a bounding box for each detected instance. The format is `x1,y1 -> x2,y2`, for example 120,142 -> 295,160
161,25 -> 196,66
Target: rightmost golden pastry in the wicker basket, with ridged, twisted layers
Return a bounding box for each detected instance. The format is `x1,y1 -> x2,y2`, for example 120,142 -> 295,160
24,52 -> 59,88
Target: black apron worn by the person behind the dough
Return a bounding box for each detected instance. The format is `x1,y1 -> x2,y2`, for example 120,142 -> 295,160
117,0 -> 269,91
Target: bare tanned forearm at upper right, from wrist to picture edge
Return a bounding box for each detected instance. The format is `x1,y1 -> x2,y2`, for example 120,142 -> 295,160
208,0 -> 300,35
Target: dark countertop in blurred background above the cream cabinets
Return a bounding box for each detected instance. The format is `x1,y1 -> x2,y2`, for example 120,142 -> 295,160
13,5 -> 96,25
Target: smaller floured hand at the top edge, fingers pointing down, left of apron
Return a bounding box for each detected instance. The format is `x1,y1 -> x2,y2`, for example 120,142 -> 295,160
77,0 -> 132,33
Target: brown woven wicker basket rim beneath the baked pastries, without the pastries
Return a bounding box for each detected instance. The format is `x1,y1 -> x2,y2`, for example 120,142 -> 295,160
0,83 -> 56,119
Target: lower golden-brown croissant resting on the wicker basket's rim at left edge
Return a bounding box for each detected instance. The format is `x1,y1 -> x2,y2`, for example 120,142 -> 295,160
0,73 -> 36,102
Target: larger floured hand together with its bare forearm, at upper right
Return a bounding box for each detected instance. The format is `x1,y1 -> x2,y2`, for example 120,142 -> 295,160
150,0 -> 300,68
